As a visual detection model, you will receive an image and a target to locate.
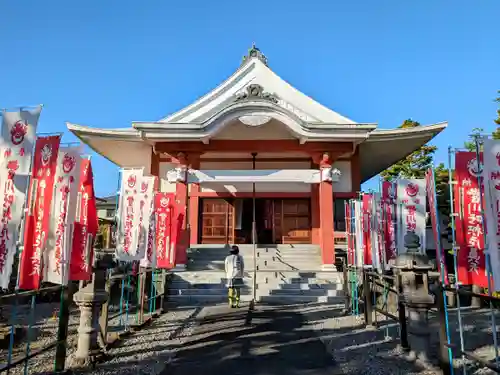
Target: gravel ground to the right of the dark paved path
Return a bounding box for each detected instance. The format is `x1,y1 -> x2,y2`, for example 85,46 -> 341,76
303,306 -> 500,375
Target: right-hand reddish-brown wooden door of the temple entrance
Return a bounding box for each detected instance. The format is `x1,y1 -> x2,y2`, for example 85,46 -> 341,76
282,199 -> 311,244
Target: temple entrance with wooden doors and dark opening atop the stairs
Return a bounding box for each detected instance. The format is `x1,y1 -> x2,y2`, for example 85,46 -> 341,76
199,198 -> 311,245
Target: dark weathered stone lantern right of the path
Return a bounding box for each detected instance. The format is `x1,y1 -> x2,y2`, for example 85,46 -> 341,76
393,232 -> 434,360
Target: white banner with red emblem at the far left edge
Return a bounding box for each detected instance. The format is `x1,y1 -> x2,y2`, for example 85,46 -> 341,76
0,106 -> 42,289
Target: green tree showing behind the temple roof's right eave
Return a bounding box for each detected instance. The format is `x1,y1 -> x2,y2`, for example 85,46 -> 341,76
380,119 -> 437,180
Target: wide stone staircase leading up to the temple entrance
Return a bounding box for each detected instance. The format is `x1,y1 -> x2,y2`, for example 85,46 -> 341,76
169,245 -> 344,304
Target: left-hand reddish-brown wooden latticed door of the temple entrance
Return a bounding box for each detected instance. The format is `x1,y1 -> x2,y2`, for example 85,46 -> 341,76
201,199 -> 234,244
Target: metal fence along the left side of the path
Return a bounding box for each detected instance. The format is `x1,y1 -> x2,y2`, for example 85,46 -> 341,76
0,266 -> 169,374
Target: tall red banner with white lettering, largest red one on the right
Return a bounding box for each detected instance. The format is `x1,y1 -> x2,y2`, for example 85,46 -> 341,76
454,152 -> 488,288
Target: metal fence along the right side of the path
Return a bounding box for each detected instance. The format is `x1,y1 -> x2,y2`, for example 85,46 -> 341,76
343,266 -> 500,375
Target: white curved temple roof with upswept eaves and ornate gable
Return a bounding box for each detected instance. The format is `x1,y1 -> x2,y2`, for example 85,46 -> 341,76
67,47 -> 447,181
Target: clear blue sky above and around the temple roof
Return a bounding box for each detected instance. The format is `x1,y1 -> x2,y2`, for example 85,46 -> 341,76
0,0 -> 500,195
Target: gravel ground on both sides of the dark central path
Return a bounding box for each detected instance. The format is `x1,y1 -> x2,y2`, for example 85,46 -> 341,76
5,303 -> 500,375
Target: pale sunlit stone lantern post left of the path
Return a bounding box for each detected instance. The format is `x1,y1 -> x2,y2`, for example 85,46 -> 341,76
68,253 -> 114,368
